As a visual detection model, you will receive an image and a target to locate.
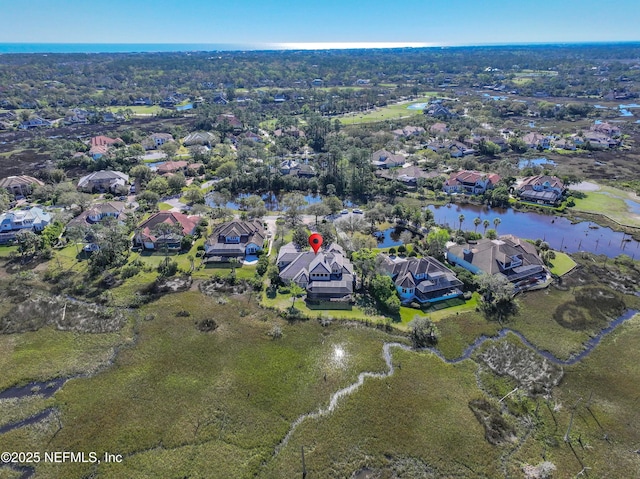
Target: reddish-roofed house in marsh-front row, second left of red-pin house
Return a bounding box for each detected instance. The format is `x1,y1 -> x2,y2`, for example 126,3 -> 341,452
133,211 -> 200,251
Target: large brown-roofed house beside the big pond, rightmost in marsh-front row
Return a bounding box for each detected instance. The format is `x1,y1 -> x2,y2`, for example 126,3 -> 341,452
447,235 -> 548,291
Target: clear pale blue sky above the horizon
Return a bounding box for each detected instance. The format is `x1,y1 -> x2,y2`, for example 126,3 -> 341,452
0,0 -> 640,47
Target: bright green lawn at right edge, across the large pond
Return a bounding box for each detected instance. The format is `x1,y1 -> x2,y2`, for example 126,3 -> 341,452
572,186 -> 640,227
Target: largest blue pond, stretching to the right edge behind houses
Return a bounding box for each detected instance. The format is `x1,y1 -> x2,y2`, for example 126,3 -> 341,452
428,204 -> 640,258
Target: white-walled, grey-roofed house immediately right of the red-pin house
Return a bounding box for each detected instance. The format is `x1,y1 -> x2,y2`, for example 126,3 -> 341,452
378,255 -> 463,303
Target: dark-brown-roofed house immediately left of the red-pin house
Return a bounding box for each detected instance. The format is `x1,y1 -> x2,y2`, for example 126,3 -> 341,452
204,219 -> 267,261
